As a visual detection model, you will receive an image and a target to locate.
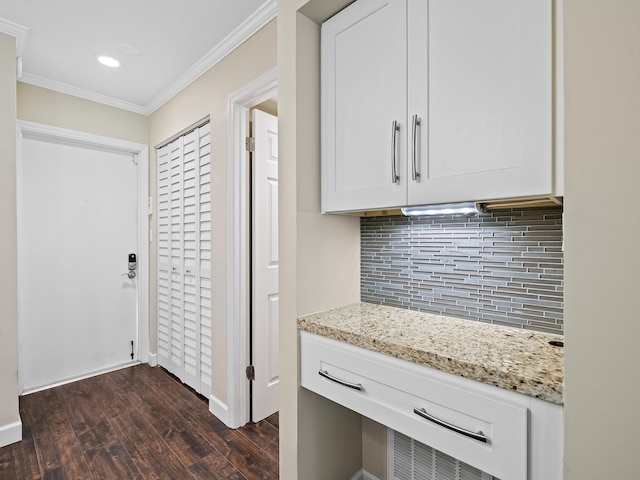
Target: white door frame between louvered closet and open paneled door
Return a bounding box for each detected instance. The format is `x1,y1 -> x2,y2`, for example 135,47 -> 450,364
221,68 -> 278,428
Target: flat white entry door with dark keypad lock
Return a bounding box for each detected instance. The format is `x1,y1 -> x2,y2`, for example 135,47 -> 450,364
19,134 -> 139,392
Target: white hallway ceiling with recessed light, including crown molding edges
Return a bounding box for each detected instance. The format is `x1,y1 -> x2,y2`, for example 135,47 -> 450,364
0,0 -> 276,114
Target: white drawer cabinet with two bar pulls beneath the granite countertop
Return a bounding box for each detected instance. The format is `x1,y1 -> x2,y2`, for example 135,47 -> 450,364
300,331 -> 562,480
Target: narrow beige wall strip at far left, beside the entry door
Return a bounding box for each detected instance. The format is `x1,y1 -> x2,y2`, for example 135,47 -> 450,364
0,33 -> 20,436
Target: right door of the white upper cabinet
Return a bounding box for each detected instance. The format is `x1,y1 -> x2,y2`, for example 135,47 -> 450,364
407,0 -> 552,205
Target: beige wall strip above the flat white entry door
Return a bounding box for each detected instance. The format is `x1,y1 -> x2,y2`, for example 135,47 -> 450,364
18,82 -> 149,145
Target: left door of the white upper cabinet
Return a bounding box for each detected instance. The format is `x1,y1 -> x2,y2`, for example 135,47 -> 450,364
322,0 -> 407,211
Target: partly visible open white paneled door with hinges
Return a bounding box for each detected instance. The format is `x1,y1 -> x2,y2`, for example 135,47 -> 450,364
251,110 -> 280,422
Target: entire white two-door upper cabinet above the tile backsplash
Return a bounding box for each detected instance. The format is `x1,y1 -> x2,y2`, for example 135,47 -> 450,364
322,0 -> 554,212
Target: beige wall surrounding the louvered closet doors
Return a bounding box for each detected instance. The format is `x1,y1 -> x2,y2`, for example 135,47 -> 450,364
149,20 -> 277,403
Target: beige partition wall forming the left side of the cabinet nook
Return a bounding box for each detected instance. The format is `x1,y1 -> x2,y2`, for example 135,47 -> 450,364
278,0 -> 362,480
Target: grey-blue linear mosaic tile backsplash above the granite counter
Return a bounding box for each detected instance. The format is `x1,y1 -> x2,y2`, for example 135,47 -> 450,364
360,207 -> 564,334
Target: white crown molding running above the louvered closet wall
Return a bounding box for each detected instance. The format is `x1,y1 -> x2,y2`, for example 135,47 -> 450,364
145,0 -> 278,115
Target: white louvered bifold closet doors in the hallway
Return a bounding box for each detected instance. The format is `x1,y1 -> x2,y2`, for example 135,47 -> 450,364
158,124 -> 211,396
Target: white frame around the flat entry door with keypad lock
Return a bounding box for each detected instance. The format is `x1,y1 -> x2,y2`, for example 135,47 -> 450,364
16,120 -> 150,394
